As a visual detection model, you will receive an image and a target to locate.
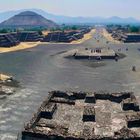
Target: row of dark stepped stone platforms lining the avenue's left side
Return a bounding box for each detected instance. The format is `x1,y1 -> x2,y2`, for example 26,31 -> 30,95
0,28 -> 91,47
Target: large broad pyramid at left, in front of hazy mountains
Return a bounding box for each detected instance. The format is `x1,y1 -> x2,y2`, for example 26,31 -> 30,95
0,11 -> 58,28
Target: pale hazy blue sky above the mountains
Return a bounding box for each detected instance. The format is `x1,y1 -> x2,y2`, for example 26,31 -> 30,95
0,0 -> 140,19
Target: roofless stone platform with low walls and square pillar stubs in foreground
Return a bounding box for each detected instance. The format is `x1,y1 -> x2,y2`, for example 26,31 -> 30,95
22,91 -> 140,140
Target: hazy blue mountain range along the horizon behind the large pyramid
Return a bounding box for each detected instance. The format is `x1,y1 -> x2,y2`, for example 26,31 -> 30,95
0,9 -> 140,24
